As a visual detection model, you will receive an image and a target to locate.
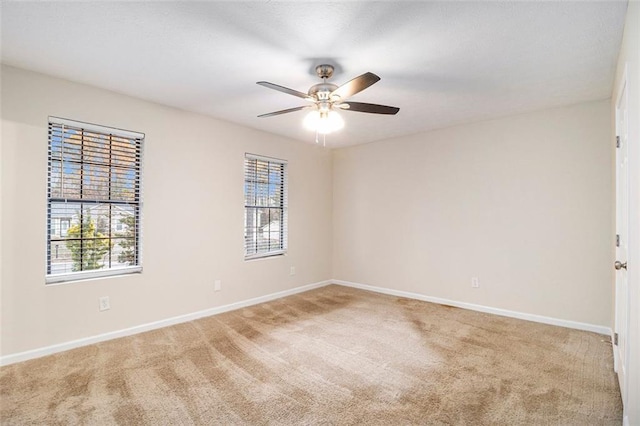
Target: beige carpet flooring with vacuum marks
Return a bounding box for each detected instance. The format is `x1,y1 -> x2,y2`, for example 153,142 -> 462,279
0,285 -> 622,426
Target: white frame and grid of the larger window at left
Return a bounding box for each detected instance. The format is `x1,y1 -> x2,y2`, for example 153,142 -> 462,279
45,116 -> 145,284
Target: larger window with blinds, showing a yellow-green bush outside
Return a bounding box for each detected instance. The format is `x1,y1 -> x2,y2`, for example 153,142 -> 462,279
46,117 -> 144,283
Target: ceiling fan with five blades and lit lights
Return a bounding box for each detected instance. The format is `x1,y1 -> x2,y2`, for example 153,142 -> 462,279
257,64 -> 400,134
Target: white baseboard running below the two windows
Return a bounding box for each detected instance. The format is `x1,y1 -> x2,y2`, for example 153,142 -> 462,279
0,280 -> 332,366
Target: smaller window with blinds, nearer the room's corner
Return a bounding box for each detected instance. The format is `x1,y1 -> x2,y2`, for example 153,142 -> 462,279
244,154 -> 287,259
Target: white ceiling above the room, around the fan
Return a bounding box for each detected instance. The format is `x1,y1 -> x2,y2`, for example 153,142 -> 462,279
1,1 -> 627,147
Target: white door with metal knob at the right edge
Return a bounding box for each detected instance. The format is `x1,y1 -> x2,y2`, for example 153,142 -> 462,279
613,73 -> 629,403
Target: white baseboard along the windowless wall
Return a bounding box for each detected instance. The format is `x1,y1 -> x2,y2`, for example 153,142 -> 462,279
331,279 -> 612,336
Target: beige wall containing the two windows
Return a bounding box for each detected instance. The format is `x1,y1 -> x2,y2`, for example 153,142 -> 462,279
0,67 -> 332,355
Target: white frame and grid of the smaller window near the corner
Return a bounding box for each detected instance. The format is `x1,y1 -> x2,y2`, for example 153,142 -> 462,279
243,152 -> 289,261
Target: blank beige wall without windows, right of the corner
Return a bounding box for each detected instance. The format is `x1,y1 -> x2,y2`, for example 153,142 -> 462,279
333,100 -> 613,327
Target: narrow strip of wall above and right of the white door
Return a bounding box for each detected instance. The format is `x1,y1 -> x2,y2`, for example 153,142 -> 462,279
611,1 -> 640,425
